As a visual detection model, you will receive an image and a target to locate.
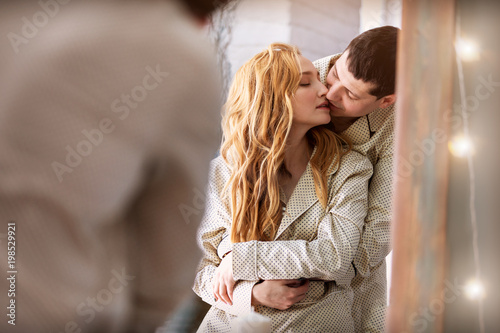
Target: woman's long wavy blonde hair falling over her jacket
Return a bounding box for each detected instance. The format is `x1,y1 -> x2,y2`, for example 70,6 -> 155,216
221,43 -> 343,243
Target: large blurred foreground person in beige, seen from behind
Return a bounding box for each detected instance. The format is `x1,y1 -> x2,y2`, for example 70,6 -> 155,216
0,0 -> 225,333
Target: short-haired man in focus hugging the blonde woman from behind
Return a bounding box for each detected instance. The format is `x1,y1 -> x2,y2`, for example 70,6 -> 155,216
253,26 -> 399,332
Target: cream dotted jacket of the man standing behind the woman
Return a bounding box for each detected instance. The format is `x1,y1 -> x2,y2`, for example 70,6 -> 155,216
314,54 -> 395,332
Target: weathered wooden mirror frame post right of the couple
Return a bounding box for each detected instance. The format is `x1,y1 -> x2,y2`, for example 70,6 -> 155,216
387,0 -> 455,333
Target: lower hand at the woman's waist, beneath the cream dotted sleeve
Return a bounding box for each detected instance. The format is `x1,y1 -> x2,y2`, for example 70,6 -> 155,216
252,280 -> 309,310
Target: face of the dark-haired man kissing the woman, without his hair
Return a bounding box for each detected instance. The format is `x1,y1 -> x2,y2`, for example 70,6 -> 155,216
326,51 -> 385,118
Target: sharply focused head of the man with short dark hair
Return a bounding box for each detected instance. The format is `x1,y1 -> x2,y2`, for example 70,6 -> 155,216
326,26 -> 399,117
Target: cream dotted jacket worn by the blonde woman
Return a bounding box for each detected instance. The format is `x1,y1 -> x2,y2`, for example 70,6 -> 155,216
193,151 -> 372,332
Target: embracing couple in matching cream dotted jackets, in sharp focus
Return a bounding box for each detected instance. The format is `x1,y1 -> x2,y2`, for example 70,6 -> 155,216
194,26 -> 399,332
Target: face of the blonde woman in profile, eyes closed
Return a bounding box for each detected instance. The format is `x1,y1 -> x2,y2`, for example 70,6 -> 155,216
292,56 -> 331,128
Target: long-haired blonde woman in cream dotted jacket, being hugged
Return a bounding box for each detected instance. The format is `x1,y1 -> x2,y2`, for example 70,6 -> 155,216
194,44 -> 372,332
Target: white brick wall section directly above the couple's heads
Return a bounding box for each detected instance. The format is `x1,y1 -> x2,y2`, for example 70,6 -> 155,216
227,0 -> 361,75
